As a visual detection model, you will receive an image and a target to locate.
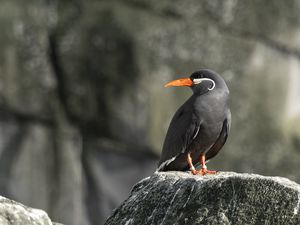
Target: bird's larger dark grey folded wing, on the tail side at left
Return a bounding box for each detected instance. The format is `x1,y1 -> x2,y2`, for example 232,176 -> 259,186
158,101 -> 200,170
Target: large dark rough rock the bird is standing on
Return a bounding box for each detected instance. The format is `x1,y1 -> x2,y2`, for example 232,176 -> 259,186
105,172 -> 300,225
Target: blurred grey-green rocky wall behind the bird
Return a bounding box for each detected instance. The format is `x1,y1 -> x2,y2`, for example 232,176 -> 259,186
0,0 -> 300,225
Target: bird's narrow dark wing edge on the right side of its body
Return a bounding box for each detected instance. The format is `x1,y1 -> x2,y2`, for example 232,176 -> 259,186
205,110 -> 231,160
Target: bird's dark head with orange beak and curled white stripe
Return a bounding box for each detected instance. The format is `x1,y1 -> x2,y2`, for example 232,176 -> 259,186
165,69 -> 229,94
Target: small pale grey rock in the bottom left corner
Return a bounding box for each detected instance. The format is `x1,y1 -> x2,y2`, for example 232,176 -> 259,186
0,196 -> 62,225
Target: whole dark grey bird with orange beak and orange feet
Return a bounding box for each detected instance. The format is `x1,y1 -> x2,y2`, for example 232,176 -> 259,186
157,69 -> 231,175
